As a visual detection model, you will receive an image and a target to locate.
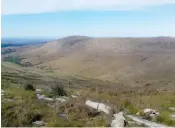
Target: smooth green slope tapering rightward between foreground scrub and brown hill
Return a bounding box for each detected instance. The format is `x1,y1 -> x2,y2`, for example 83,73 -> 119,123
1,61 -> 122,90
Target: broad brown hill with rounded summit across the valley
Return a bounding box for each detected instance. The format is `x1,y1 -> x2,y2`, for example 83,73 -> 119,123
20,36 -> 175,86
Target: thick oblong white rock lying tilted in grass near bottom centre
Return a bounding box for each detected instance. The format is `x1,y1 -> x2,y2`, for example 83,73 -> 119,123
86,100 -> 111,114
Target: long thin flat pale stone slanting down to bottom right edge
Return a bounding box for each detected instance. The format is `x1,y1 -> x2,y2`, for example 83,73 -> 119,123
127,115 -> 168,127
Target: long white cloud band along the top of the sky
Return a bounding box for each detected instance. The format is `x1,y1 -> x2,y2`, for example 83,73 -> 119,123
2,0 -> 175,15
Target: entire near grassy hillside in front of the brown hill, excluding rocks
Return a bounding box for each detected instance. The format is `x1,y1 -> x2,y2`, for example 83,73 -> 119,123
1,62 -> 175,127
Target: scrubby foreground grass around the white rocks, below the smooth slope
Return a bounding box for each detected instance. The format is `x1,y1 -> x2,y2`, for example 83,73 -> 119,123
2,77 -> 175,127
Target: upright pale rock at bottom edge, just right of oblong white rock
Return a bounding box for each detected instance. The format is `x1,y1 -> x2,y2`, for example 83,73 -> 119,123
111,112 -> 125,127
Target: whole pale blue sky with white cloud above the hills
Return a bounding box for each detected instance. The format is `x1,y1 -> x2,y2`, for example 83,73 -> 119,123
1,0 -> 175,38
